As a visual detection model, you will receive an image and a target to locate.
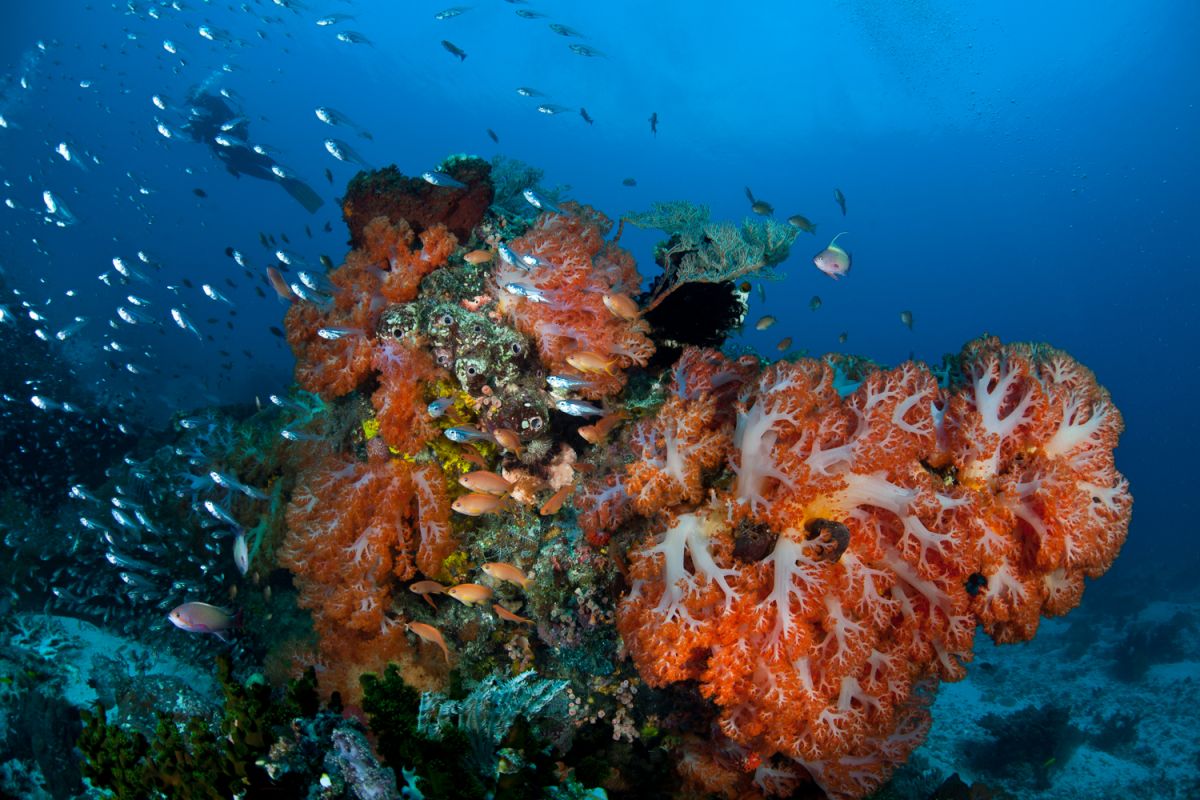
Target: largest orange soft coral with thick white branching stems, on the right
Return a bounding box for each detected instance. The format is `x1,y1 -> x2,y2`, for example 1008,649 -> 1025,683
618,338 -> 1132,798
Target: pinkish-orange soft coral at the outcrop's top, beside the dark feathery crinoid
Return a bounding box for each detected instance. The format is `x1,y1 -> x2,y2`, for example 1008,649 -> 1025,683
492,204 -> 654,399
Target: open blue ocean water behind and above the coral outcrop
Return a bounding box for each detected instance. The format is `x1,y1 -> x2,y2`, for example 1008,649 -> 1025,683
0,0 -> 1200,796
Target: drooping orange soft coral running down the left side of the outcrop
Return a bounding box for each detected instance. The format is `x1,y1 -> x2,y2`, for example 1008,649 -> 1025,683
280,217 -> 457,702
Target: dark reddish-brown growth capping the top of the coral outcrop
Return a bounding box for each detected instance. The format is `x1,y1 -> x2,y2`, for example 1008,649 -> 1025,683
342,157 -> 493,247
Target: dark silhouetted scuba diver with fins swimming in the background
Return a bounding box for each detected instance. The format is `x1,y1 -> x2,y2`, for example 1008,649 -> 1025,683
184,86 -> 324,213
